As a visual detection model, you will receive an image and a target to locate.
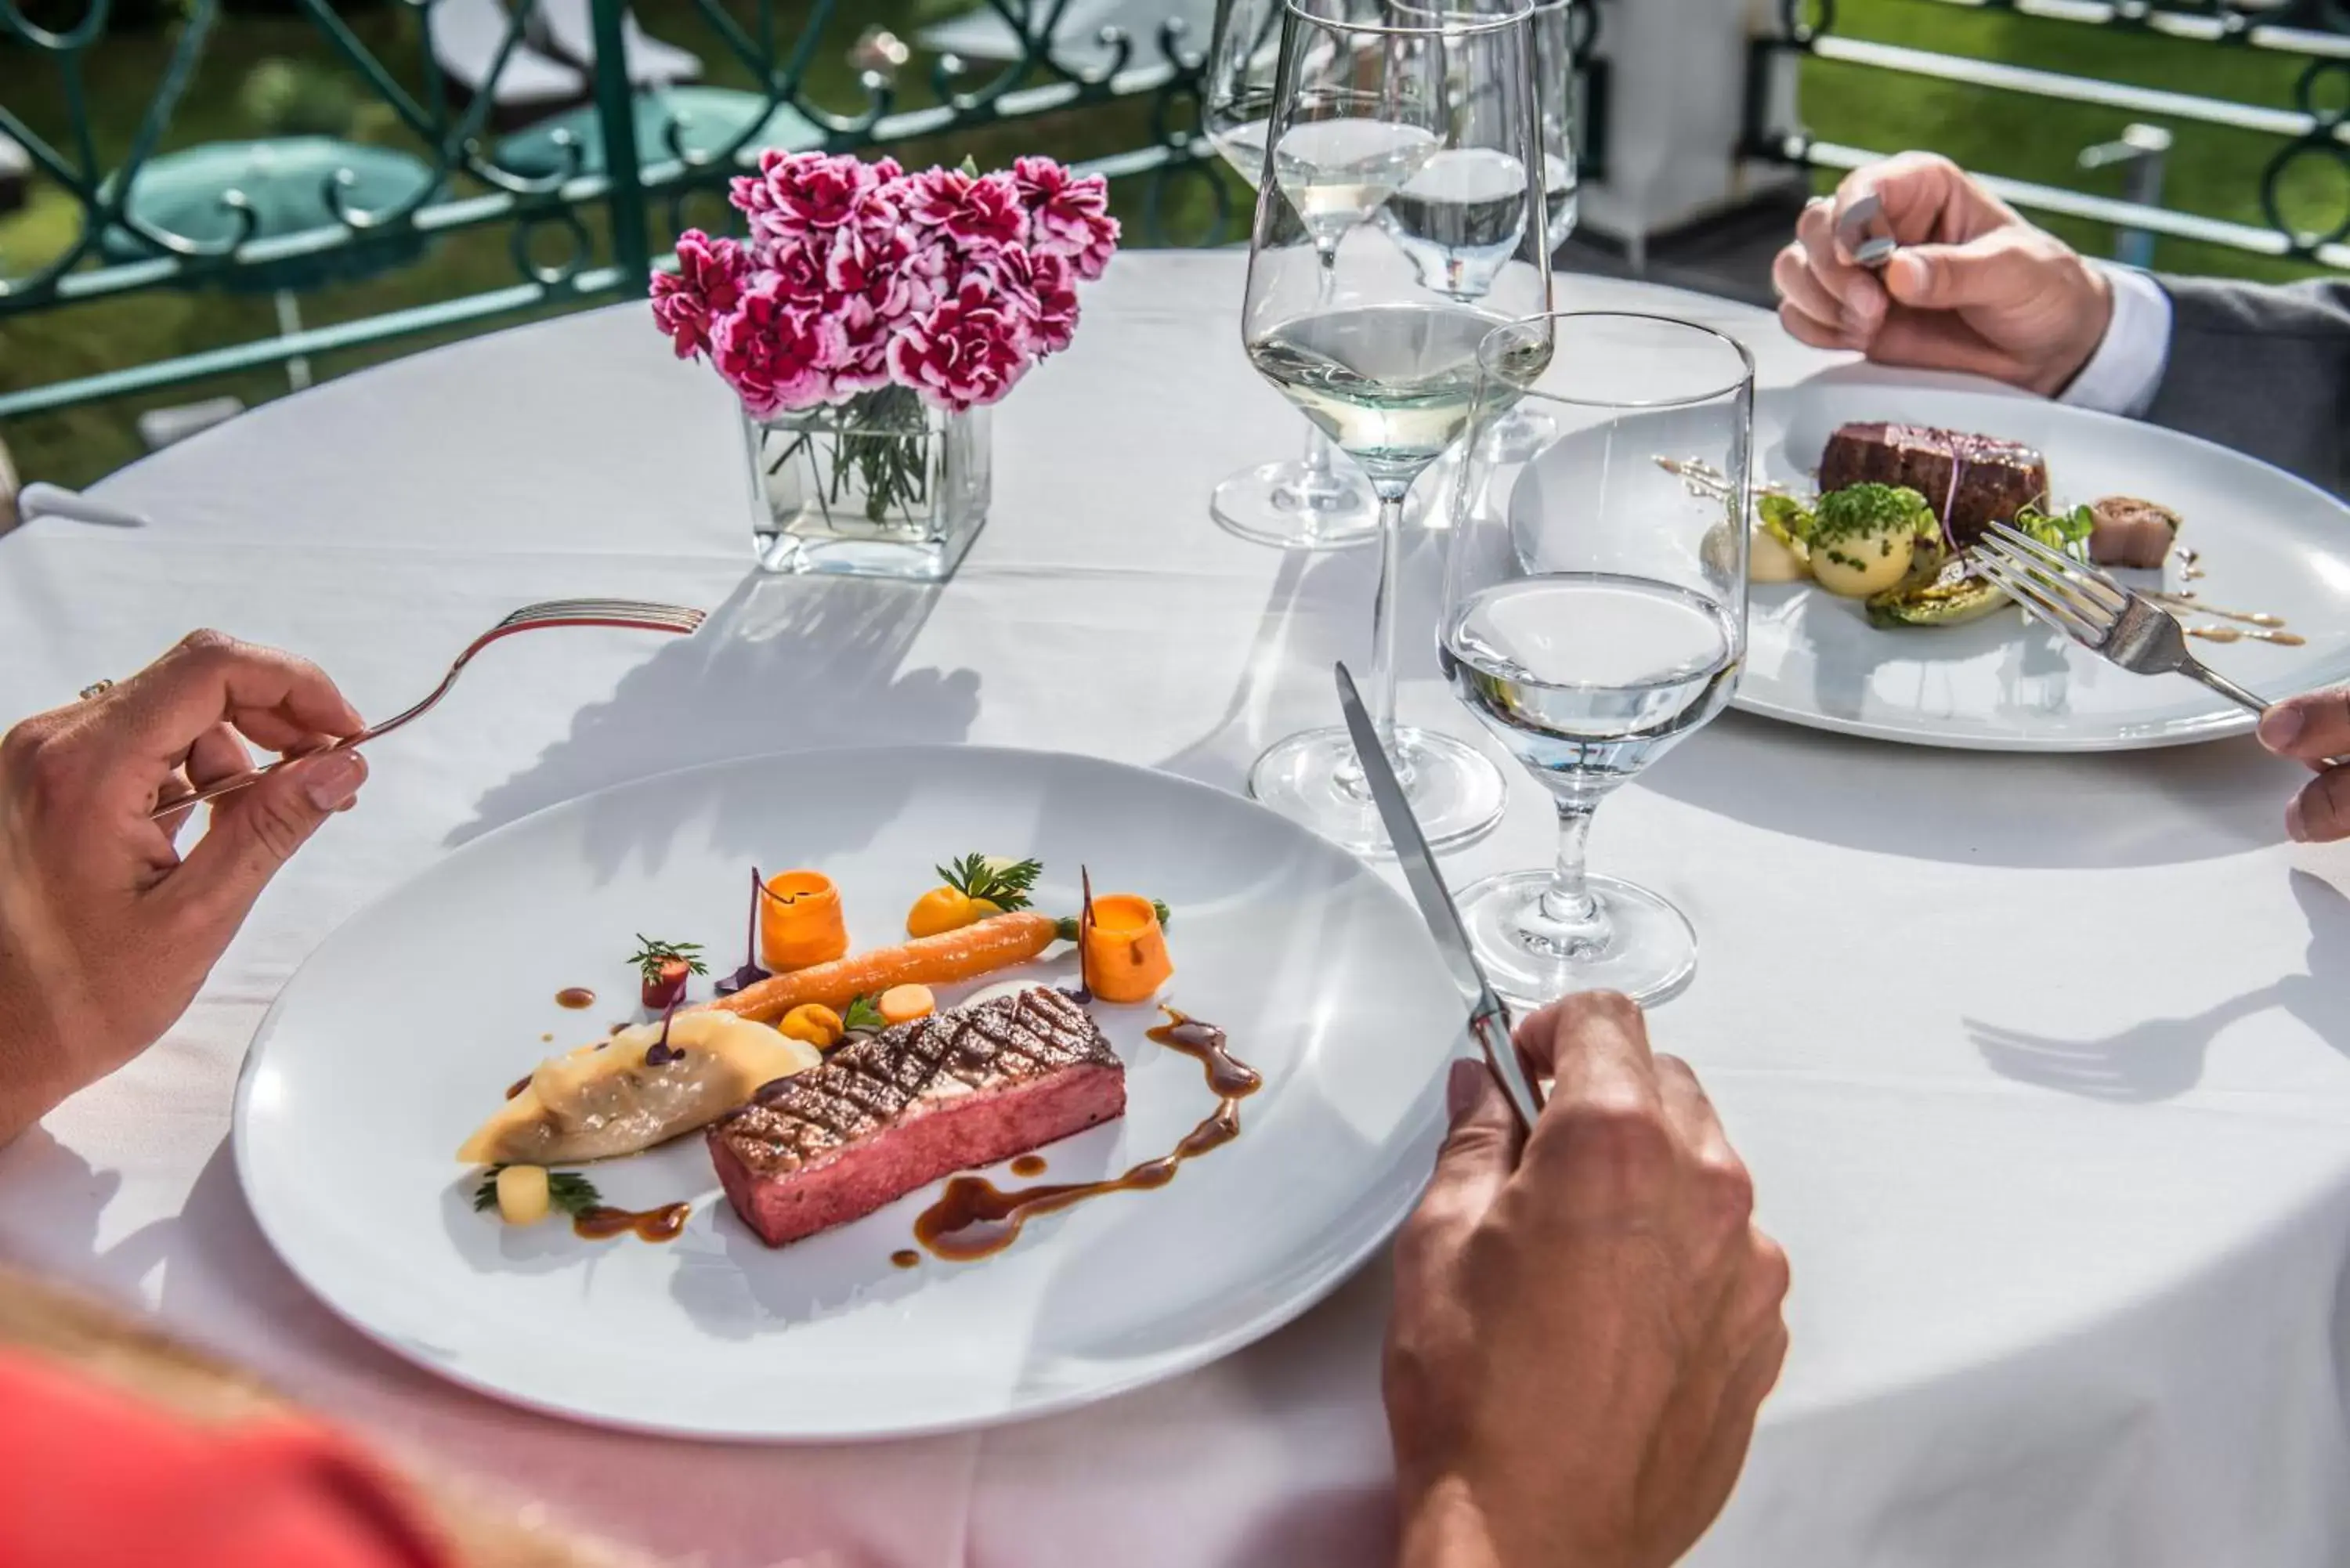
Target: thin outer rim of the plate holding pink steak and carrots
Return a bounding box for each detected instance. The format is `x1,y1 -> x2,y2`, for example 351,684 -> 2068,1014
228,740 -> 1469,1448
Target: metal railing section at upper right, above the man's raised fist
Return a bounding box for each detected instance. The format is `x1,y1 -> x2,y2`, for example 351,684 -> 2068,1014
1744,0 -> 2350,268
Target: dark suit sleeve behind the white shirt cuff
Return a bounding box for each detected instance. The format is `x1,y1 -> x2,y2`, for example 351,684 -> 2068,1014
2146,277 -> 2350,493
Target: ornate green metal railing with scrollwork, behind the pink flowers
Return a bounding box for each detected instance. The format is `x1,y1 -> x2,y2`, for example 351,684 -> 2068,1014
0,0 -> 1231,418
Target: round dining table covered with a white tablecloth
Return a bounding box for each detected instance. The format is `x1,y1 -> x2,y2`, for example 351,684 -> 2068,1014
0,251 -> 2350,1568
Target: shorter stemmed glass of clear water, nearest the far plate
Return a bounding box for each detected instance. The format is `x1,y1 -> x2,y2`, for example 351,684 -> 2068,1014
1438,313 -> 1753,1006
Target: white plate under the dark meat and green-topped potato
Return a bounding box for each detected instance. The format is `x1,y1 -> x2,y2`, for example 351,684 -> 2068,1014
1737,378 -> 2350,752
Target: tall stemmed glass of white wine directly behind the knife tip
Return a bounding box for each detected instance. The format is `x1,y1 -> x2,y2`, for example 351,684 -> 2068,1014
1241,0 -> 1551,851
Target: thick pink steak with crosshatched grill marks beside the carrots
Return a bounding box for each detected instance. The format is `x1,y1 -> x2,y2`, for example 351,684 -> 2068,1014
710,988 -> 1126,1246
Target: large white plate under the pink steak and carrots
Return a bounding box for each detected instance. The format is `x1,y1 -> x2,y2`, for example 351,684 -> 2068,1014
235,747 -> 1464,1439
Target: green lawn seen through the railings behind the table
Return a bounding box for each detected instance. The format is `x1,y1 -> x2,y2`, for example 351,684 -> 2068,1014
0,0 -> 2350,484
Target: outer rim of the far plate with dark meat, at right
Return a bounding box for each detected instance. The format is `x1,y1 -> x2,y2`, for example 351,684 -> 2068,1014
1730,378 -> 2350,754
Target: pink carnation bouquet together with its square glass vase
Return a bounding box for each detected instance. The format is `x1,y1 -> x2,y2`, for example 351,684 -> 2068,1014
653,150 -> 1119,564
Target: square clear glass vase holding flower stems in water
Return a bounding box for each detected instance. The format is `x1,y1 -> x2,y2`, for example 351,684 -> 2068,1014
745,385 -> 989,583
